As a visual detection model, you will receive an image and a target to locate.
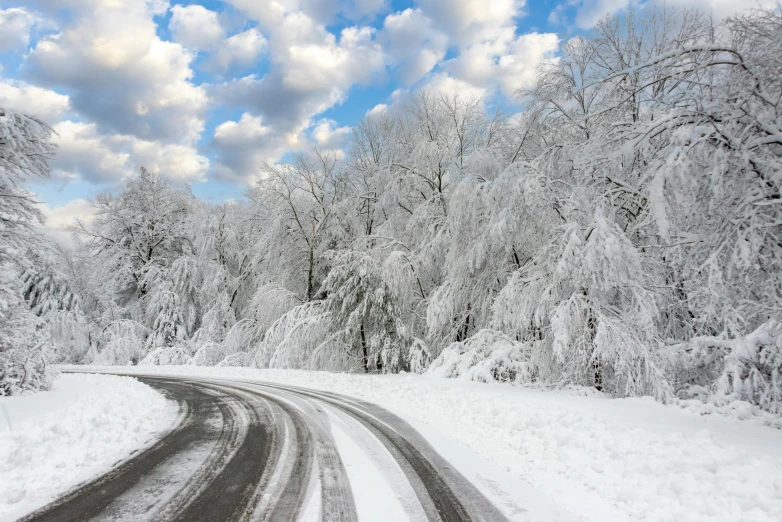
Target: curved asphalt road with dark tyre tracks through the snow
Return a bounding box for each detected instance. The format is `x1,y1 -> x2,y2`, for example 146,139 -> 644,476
22,376 -> 506,522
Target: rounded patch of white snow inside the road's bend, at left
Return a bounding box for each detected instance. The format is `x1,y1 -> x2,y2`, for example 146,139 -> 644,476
0,374 -> 179,520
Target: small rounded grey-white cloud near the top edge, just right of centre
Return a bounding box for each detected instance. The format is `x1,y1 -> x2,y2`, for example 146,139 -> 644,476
378,9 -> 448,85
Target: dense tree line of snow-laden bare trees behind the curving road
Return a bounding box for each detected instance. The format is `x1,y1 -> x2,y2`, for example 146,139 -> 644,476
0,5 -> 782,412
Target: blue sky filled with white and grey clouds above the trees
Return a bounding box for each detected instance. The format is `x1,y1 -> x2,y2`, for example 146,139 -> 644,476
0,0 -> 766,238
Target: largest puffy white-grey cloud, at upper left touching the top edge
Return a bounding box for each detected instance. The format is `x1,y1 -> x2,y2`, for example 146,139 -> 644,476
28,1 -> 207,142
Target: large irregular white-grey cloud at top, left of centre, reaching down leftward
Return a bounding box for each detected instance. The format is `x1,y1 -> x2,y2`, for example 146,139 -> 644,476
212,2 -> 385,181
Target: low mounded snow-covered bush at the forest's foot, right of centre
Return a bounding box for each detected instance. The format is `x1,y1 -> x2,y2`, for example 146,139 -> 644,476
426,329 -> 534,384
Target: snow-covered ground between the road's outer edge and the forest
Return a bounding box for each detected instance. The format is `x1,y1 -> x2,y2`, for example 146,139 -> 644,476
72,366 -> 782,521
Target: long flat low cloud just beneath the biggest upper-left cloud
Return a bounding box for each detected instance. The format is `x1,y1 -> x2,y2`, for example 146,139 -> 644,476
52,121 -> 209,185
